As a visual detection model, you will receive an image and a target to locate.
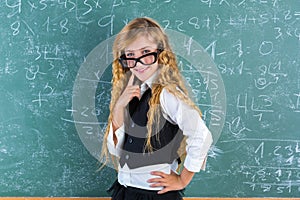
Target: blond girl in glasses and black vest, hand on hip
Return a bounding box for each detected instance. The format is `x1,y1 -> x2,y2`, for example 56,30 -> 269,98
102,18 -> 212,200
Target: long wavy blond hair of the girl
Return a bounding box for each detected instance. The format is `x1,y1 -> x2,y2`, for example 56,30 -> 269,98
101,18 -> 201,170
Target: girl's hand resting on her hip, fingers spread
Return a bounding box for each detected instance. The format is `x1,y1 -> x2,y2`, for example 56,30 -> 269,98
148,171 -> 187,194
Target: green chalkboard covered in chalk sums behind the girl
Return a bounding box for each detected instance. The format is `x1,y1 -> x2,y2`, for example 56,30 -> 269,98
0,0 -> 300,197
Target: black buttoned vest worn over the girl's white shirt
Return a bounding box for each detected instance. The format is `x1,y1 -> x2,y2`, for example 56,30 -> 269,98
120,89 -> 183,169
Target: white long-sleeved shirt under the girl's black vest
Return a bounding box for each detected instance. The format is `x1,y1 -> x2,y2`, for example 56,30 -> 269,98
107,72 -> 212,190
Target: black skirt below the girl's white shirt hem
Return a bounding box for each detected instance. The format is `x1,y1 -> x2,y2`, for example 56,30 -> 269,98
108,181 -> 183,200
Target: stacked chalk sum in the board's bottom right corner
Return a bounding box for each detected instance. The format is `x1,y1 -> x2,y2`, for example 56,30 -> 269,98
241,140 -> 300,194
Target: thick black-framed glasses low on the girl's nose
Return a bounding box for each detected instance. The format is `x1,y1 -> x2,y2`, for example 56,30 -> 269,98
119,51 -> 161,68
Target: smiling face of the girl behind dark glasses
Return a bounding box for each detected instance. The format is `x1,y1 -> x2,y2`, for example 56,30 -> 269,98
125,36 -> 158,82
